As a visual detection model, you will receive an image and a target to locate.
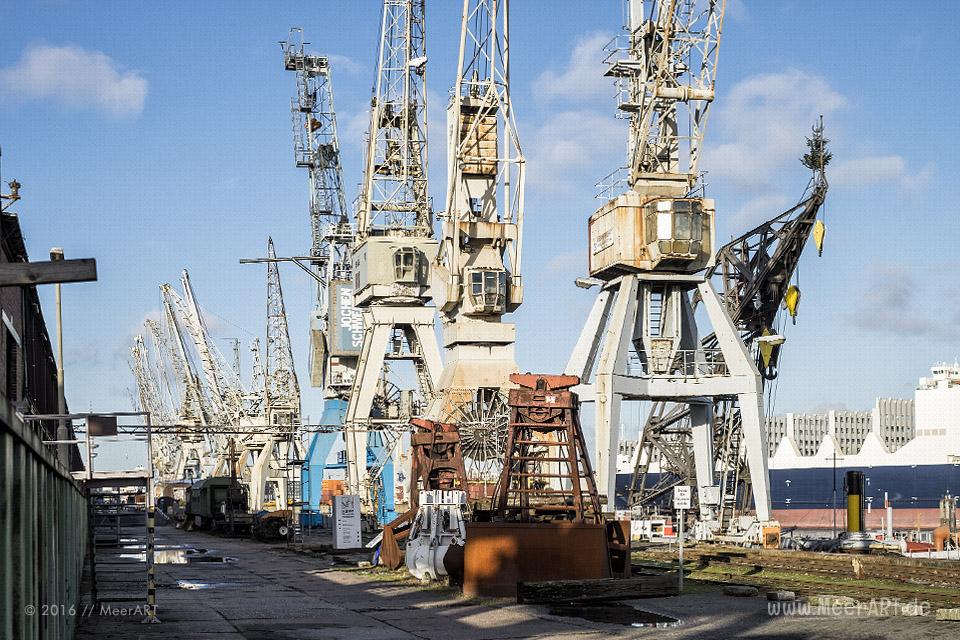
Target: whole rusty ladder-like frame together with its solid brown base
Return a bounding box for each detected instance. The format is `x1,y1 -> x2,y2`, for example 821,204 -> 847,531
463,374 -> 630,596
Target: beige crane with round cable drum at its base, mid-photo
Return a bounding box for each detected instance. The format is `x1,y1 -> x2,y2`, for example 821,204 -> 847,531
427,0 -> 525,484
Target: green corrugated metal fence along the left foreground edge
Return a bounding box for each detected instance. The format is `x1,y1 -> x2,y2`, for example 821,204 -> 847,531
0,399 -> 87,640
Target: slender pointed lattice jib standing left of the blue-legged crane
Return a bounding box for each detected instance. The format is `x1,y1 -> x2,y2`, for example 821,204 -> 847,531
264,238 -> 300,426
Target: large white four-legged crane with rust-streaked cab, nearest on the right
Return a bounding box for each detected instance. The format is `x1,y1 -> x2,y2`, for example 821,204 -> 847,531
566,0 -> 773,541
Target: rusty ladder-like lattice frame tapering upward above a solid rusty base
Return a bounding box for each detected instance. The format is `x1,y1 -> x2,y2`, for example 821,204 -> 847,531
493,373 -> 603,523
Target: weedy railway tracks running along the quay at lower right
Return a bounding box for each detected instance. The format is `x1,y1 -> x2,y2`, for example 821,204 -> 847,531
633,547 -> 960,606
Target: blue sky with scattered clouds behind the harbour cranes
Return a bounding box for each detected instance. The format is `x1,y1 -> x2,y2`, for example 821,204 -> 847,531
0,0 -> 960,462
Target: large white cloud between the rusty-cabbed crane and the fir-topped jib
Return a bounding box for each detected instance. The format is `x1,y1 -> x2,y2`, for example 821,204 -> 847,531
701,69 -> 846,191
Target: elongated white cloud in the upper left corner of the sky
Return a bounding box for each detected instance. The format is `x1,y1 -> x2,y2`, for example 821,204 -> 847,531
0,45 -> 148,116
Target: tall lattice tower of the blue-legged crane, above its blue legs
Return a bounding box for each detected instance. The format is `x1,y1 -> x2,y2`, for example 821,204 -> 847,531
280,28 -> 363,399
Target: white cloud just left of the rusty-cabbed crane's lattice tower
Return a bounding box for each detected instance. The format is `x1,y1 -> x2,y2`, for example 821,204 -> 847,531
533,33 -> 614,107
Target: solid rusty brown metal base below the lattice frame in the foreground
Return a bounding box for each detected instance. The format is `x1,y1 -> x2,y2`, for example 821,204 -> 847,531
463,522 -> 610,597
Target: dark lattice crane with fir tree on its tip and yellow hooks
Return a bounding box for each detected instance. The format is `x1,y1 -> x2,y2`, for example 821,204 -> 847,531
618,121 -> 832,540
